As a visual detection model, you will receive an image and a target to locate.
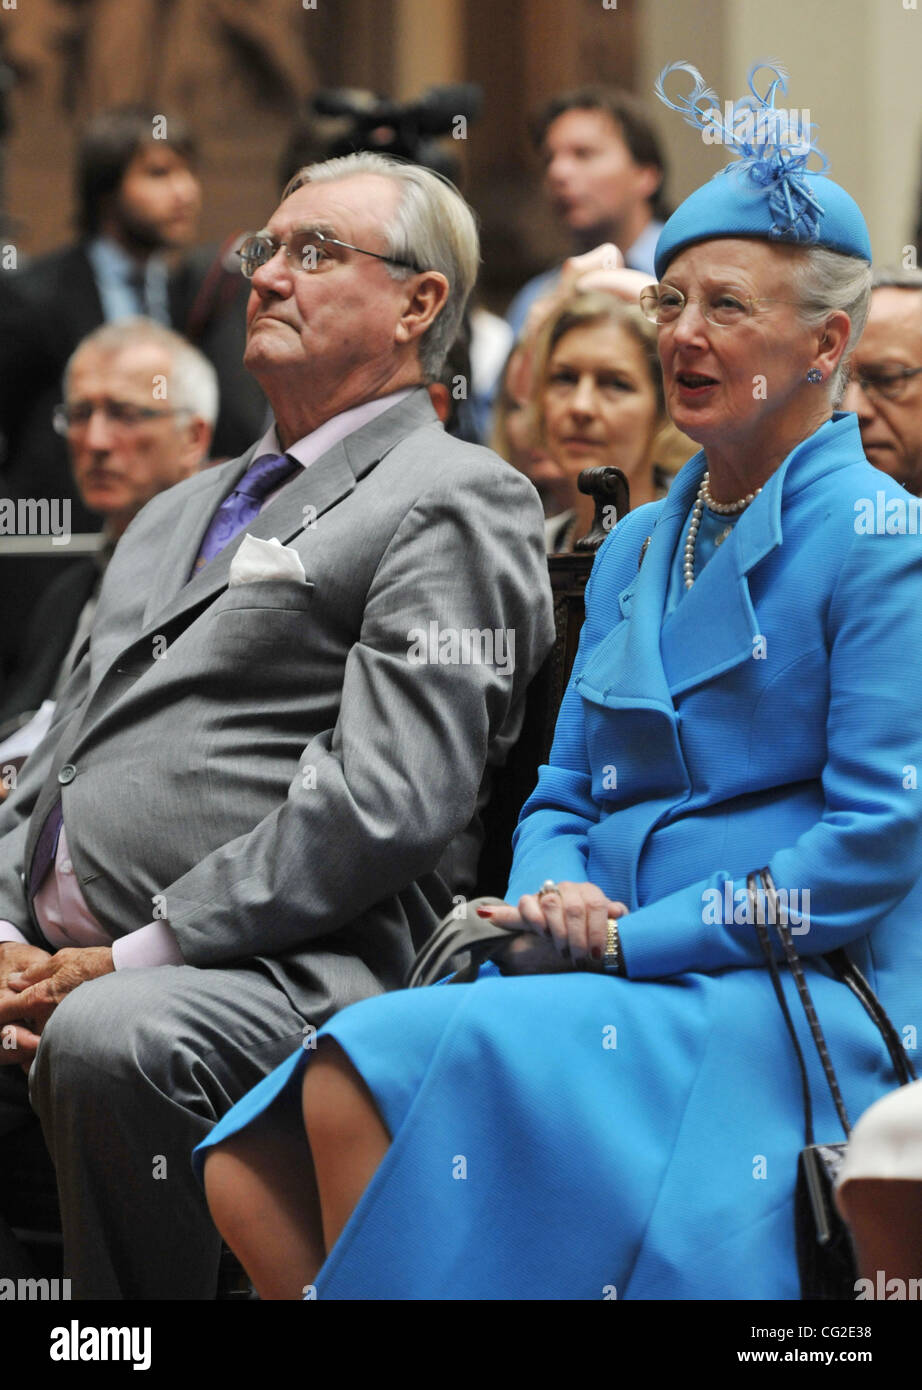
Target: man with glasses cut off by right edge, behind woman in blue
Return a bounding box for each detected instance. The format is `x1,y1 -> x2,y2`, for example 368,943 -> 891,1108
843,270 -> 922,498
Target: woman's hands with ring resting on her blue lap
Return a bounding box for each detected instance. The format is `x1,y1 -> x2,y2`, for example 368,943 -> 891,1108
477,883 -> 627,974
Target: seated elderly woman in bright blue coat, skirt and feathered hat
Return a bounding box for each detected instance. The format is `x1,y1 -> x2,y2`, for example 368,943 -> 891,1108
197,74 -> 922,1300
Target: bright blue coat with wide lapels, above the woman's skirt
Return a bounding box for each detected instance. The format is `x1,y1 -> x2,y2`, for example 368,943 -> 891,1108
508,414 -> 922,1047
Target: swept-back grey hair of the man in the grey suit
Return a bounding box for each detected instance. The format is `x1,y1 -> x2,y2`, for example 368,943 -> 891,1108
282,152 -> 480,381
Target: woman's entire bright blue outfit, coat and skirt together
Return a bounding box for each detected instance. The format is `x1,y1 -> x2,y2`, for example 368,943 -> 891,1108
196,416 -> 922,1300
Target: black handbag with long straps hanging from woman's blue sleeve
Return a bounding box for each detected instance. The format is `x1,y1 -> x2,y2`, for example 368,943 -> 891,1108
747,869 -> 915,1301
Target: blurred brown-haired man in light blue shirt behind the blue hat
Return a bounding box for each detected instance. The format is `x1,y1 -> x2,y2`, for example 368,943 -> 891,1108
506,86 -> 666,336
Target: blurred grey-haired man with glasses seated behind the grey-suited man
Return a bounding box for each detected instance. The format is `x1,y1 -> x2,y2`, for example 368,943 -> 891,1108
0,318 -> 218,778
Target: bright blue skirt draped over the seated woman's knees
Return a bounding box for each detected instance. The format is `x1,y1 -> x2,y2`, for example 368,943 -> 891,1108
195,966 -> 896,1300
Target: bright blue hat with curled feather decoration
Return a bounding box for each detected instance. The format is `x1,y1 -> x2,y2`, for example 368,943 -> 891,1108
655,61 -> 871,278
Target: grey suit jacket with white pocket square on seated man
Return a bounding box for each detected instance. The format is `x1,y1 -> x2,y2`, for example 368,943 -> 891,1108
0,389 -> 553,1012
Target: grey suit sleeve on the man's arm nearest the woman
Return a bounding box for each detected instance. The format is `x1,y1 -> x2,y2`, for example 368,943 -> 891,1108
155,450 -> 553,965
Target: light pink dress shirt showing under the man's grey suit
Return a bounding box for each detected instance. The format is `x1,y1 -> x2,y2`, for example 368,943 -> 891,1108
0,386 -> 416,970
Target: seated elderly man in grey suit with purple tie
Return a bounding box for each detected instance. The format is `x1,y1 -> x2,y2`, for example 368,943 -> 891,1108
0,154 -> 552,1298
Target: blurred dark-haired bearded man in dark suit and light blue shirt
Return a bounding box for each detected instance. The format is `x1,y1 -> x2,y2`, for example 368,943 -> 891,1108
0,107 -> 267,695
